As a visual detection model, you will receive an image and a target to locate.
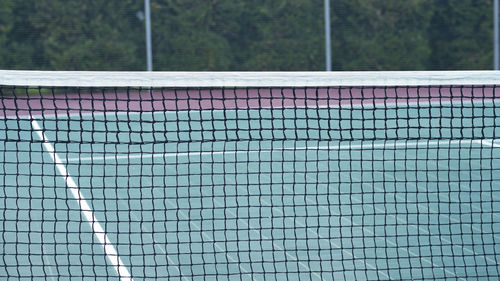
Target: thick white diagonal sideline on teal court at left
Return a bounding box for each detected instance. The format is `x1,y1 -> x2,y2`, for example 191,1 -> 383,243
31,120 -> 133,281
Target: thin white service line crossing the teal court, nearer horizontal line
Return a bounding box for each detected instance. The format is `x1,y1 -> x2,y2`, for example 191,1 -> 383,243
66,139 -> 484,163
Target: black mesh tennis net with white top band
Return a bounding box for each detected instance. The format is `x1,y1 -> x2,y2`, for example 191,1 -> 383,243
0,71 -> 500,280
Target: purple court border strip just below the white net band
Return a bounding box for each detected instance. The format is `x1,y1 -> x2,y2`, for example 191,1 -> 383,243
0,86 -> 500,117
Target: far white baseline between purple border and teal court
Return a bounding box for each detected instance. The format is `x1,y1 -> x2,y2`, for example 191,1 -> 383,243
5,97 -> 500,121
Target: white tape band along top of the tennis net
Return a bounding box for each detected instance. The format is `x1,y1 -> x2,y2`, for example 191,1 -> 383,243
0,70 -> 500,88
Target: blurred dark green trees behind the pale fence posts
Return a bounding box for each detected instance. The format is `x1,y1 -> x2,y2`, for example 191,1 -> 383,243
0,0 -> 493,71
